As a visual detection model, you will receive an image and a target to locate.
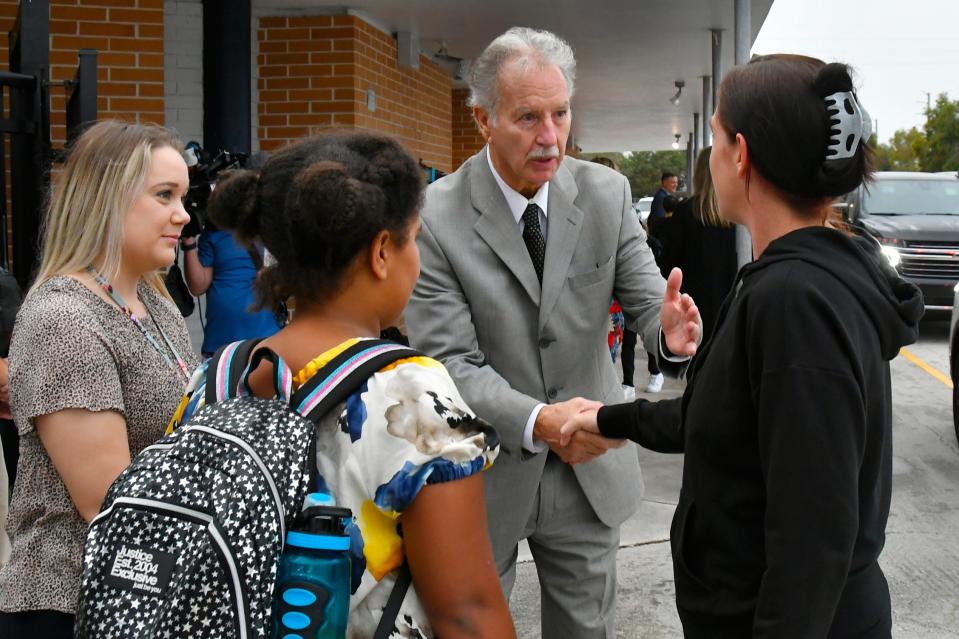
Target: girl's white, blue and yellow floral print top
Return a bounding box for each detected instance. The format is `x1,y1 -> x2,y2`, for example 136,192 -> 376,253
171,339 -> 499,639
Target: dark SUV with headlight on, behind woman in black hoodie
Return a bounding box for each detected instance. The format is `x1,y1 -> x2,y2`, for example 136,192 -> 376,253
836,171 -> 959,311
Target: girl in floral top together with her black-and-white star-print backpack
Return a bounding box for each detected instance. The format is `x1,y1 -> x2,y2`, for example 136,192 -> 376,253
78,133 -> 515,639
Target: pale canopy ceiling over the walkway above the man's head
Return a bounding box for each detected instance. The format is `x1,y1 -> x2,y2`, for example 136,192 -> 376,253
253,0 -> 773,152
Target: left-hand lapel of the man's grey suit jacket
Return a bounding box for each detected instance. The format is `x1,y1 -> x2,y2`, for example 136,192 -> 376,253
469,152 -> 552,305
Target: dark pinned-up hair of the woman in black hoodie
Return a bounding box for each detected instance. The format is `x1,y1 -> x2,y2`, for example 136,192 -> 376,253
717,54 -> 872,209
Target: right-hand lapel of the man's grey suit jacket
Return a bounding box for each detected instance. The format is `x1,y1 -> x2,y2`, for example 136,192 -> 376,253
540,164 -> 584,328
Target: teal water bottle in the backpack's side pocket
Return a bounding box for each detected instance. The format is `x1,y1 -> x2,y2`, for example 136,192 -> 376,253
273,493 -> 352,639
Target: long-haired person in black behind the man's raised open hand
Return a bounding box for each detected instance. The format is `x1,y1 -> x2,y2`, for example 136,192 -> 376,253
663,147 -> 737,342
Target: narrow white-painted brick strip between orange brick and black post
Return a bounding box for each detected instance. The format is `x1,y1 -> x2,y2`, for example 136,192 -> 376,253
163,0 -> 203,145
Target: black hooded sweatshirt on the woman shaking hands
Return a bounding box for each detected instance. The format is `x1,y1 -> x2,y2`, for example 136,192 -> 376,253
598,227 -> 923,639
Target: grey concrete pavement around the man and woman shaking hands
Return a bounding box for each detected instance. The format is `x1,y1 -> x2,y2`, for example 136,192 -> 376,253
510,316 -> 959,639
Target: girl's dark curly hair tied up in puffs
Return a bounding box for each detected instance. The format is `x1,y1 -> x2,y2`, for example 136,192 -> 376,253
208,133 -> 423,307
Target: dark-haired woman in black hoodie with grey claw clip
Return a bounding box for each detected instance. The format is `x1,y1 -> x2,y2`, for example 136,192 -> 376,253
563,55 -> 923,639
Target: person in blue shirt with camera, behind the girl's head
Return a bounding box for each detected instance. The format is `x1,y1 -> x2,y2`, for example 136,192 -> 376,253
180,200 -> 285,357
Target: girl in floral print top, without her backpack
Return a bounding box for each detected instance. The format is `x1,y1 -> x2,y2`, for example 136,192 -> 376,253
199,133 -> 515,639
